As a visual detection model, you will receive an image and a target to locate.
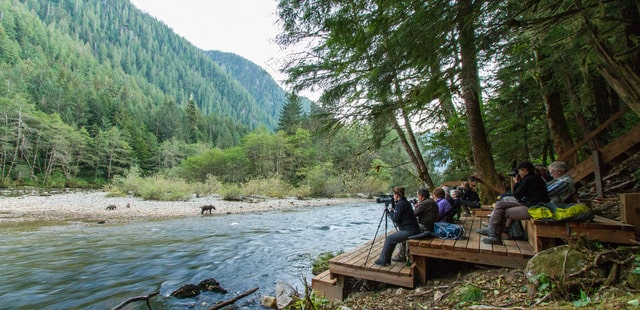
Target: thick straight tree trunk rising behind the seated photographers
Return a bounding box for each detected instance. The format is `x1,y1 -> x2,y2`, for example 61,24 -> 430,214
457,0 -> 502,203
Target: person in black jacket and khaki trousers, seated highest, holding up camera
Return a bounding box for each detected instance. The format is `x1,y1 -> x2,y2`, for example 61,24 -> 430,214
478,161 -> 550,244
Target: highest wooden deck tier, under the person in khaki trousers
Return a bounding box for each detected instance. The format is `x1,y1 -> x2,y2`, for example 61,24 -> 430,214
522,216 -> 635,253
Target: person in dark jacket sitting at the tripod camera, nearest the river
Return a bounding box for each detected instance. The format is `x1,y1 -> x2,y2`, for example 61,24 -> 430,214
375,187 -> 420,266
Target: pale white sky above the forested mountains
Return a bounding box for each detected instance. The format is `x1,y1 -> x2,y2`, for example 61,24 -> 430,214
131,0 -> 294,92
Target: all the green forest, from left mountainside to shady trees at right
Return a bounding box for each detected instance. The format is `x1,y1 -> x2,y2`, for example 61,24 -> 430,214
0,0 -> 640,201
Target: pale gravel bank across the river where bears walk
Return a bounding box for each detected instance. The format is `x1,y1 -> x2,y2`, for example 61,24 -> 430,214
0,192 -> 371,224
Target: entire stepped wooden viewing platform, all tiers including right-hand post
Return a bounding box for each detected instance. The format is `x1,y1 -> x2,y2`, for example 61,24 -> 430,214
311,194 -> 640,300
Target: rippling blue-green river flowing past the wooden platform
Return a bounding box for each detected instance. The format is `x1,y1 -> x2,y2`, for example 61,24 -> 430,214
0,203 -> 385,309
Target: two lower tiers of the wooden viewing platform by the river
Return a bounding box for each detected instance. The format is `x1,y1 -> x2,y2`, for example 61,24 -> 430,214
312,216 -> 534,300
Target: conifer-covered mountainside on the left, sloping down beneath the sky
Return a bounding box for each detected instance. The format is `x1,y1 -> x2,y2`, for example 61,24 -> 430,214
0,0 -> 292,184
